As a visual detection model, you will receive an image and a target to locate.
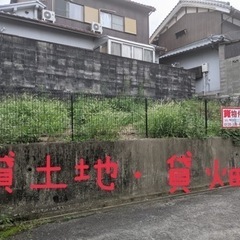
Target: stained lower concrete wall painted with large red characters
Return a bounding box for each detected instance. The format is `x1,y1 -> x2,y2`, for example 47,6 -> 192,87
0,138 -> 240,218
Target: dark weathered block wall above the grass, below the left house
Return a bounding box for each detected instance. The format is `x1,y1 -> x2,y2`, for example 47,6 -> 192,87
0,34 -> 195,98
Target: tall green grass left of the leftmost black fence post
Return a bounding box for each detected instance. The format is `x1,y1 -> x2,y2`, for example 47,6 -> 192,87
0,94 -> 69,143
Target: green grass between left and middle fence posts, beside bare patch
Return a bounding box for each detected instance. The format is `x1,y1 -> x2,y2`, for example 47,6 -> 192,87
74,97 -> 144,141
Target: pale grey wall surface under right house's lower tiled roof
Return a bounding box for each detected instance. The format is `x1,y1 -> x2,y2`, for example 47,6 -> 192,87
160,47 -> 220,93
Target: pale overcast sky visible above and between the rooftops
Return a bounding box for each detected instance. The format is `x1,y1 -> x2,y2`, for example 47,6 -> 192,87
0,0 -> 240,34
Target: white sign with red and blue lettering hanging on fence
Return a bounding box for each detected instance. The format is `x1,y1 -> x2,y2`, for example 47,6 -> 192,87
221,107 -> 240,128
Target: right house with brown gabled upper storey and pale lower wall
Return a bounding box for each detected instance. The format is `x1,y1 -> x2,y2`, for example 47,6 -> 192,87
150,0 -> 240,94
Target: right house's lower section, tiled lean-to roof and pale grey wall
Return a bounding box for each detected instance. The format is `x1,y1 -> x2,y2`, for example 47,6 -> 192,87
159,35 -> 228,94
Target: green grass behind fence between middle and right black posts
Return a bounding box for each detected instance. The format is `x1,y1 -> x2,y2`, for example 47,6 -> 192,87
139,100 -> 205,138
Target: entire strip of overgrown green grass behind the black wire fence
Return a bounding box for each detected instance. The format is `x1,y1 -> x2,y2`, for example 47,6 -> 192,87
0,94 -> 240,143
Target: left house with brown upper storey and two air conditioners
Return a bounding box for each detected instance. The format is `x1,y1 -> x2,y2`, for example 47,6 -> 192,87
0,0 -> 155,62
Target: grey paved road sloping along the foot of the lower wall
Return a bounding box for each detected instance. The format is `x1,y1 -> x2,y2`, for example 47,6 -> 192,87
7,188 -> 240,240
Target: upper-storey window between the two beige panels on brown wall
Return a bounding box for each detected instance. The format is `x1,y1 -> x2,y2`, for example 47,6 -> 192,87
100,12 -> 123,31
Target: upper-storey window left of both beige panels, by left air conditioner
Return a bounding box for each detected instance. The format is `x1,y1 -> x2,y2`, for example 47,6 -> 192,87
54,0 -> 83,21
